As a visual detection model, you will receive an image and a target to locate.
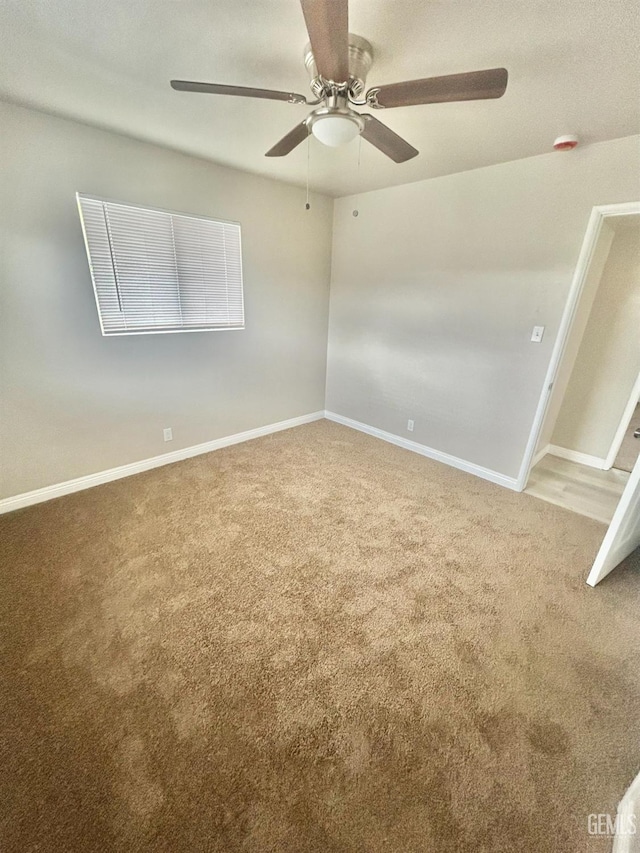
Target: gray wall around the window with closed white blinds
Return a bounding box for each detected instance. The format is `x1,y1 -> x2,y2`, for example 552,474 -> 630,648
0,104 -> 332,497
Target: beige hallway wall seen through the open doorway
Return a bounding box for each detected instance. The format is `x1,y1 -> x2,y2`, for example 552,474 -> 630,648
551,216 -> 640,459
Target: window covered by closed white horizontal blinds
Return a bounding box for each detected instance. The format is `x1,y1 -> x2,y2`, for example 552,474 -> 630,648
77,193 -> 244,335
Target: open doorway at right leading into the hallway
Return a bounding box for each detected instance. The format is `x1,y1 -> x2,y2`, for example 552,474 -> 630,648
519,202 -> 640,582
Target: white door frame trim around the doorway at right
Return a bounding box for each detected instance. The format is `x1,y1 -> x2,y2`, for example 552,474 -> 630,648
516,201 -> 640,491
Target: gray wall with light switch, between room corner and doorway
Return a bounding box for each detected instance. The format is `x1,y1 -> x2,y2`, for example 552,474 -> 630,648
327,137 -> 640,477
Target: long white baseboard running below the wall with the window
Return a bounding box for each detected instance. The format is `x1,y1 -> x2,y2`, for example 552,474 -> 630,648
0,412 -> 324,513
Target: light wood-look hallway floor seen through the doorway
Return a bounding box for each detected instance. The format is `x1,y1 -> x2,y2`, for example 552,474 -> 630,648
525,454 -> 629,524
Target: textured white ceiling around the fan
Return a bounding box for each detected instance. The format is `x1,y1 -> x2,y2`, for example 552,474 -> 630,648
0,0 -> 640,196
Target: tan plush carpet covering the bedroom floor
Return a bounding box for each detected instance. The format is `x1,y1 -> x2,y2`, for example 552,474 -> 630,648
0,421 -> 640,853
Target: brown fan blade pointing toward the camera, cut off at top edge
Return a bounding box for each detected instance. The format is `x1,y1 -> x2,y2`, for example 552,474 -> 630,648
300,0 -> 349,83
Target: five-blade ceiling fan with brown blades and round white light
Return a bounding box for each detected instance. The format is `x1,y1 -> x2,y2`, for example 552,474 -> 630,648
171,0 -> 508,163
